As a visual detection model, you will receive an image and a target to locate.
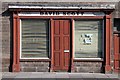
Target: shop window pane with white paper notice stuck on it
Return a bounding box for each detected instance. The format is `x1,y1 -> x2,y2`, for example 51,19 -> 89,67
75,20 -> 103,58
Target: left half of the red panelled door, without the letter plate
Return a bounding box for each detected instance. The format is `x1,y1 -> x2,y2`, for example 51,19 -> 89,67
53,20 -> 61,69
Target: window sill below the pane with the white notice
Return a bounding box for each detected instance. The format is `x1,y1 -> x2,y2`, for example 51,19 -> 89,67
73,58 -> 104,62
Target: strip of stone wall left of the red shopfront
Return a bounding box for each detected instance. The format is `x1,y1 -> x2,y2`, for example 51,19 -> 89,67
2,3 -> 13,72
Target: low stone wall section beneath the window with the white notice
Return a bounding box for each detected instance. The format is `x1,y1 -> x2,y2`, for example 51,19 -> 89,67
73,62 -> 103,73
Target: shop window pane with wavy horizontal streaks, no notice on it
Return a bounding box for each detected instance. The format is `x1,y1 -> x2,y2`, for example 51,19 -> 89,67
21,19 -> 49,58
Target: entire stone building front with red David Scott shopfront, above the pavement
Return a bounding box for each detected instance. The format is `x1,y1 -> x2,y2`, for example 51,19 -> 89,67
2,1 -> 120,73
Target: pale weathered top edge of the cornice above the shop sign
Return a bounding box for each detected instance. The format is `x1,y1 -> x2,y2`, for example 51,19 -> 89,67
8,4 -> 115,9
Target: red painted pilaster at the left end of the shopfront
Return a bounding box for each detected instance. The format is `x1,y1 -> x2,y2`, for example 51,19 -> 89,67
12,13 -> 20,72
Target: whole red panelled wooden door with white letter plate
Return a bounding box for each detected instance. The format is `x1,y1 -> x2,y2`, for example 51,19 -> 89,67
52,20 -> 70,71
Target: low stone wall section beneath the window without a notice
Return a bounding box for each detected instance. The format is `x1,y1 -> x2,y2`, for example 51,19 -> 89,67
20,62 -> 50,72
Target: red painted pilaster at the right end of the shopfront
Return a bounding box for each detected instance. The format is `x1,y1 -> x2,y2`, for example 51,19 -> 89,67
105,15 -> 112,72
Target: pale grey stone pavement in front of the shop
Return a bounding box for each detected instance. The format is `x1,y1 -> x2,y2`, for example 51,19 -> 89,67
2,72 -> 120,80
